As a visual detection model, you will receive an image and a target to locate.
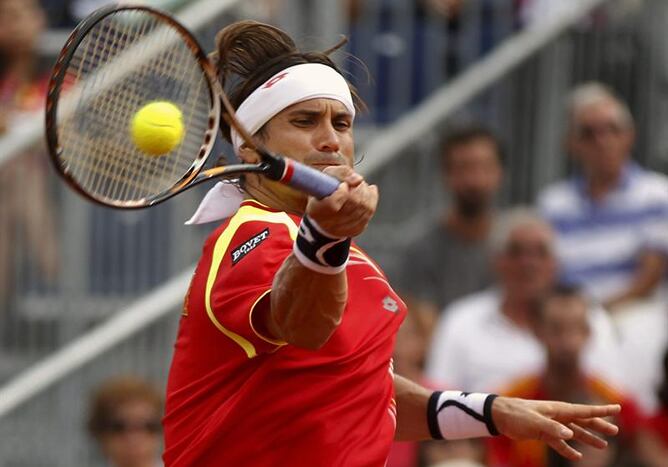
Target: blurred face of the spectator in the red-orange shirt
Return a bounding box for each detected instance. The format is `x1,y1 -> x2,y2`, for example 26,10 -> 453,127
538,297 -> 589,369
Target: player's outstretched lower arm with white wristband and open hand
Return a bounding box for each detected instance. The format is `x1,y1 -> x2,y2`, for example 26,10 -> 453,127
394,375 -> 621,460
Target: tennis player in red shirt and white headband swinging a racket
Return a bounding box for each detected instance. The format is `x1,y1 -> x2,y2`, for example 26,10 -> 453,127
164,22 -> 619,467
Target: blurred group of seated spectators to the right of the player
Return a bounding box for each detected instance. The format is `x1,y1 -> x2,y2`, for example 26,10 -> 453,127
391,82 -> 668,467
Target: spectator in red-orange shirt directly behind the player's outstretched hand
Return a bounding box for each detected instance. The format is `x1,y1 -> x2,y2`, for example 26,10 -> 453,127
487,286 -> 640,467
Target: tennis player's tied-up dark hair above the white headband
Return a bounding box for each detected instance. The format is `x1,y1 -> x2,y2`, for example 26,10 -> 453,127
212,20 -> 365,141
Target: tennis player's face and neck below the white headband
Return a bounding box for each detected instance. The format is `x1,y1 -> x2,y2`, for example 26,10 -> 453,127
242,99 -> 354,212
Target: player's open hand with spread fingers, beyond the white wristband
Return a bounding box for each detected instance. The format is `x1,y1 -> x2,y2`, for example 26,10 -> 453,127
492,397 -> 621,460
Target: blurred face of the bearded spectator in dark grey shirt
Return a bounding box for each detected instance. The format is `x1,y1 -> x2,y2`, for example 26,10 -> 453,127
444,138 -> 502,217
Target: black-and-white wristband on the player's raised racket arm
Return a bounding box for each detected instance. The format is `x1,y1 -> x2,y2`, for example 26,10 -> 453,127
293,216 -> 351,274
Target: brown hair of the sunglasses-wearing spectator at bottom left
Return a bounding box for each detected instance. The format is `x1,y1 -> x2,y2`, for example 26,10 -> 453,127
87,376 -> 163,440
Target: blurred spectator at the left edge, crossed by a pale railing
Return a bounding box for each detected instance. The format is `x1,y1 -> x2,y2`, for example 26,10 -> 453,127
0,0 -> 58,318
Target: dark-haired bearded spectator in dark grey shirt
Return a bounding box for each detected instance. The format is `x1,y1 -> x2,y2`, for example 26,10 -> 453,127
394,126 -> 503,335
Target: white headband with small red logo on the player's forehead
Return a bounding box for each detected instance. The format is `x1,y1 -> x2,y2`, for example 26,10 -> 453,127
231,63 -> 355,155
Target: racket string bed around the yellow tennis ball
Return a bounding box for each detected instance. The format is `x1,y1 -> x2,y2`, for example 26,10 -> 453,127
58,10 -> 217,202
